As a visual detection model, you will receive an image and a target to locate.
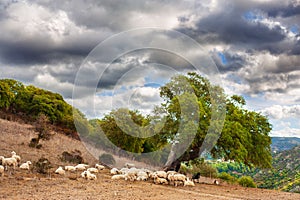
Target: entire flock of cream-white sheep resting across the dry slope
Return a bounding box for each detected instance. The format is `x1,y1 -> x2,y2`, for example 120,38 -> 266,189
0,151 -> 216,186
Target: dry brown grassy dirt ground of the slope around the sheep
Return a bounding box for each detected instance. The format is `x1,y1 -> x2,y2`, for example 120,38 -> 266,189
0,119 -> 300,200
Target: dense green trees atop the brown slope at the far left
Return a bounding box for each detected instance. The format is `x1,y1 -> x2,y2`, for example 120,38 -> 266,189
0,79 -> 83,135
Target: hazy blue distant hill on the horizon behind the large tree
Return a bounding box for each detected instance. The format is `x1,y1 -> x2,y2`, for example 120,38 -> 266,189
271,137 -> 300,152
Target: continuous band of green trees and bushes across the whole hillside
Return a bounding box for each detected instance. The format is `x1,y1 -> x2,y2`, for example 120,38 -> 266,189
0,72 -> 272,182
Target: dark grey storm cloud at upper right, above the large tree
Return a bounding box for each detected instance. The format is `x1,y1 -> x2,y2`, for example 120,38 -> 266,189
178,4 -> 286,53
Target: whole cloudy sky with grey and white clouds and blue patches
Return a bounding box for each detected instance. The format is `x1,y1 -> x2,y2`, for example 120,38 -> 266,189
0,0 -> 300,137
